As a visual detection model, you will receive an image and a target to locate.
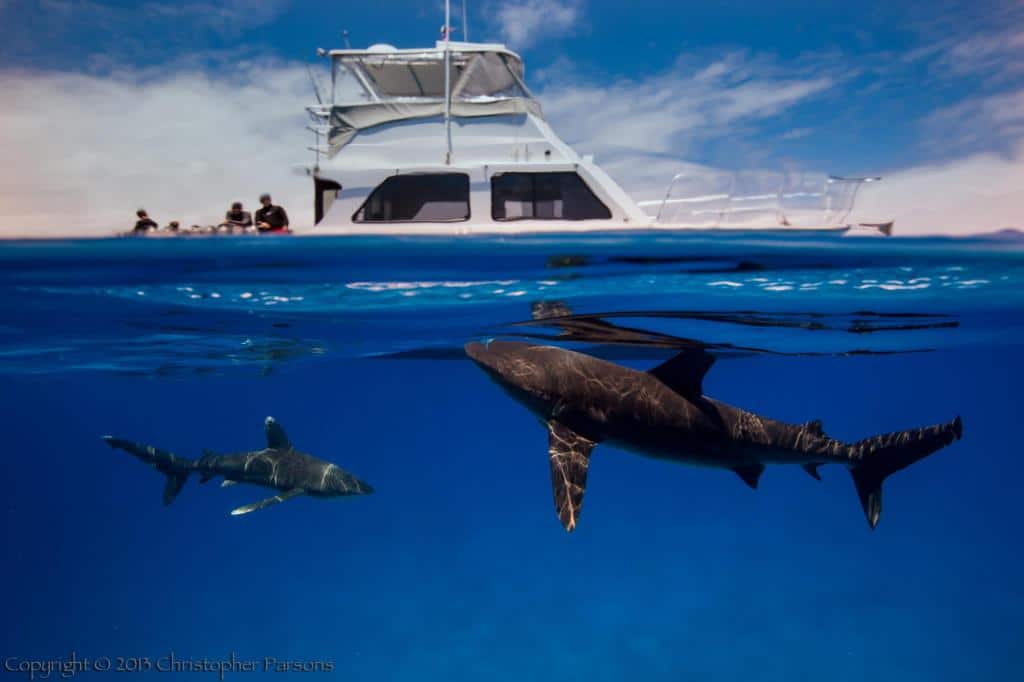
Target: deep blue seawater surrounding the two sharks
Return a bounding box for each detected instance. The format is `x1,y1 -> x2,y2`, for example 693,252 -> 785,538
0,233 -> 1024,682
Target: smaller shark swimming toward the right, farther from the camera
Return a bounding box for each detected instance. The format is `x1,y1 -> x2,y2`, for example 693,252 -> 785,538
103,417 -> 374,516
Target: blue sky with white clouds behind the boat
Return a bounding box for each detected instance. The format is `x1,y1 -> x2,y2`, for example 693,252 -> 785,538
0,0 -> 1024,237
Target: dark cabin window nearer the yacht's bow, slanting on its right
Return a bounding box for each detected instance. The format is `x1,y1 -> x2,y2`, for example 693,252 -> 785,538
490,172 -> 611,220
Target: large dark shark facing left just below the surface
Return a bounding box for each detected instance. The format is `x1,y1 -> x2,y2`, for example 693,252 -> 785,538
465,341 -> 963,531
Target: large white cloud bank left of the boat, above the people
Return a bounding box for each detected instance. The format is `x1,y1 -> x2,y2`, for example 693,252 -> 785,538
0,65 -> 312,237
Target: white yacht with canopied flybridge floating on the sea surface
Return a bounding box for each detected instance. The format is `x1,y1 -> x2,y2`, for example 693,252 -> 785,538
300,23 -> 891,235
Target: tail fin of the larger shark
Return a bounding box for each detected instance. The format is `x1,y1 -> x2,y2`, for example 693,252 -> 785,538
850,417 -> 964,528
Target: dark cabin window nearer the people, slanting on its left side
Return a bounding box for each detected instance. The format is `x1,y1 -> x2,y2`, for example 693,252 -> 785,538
352,173 -> 469,222
